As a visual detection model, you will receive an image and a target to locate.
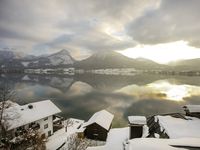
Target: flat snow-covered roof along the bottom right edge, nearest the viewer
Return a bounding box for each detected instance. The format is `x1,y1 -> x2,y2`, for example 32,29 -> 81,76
126,138 -> 200,150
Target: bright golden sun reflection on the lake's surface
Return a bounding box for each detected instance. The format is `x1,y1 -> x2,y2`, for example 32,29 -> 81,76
116,80 -> 200,102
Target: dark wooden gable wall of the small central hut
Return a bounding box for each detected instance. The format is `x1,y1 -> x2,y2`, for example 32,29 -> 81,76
84,123 -> 108,141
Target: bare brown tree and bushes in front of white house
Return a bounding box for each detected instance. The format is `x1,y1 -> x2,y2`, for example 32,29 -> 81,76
0,84 -> 45,150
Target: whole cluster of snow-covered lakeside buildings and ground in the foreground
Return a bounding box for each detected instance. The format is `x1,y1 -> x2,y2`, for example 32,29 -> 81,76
0,100 -> 200,150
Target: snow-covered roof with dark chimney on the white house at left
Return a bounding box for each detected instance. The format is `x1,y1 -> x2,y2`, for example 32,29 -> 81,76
2,100 -> 61,130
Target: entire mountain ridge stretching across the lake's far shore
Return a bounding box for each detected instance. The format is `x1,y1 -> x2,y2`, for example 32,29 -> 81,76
0,49 -> 200,71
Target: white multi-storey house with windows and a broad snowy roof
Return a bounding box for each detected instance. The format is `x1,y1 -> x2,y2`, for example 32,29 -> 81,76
2,100 -> 61,137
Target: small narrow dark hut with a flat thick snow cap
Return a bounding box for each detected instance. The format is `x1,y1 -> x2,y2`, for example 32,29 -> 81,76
128,116 -> 147,139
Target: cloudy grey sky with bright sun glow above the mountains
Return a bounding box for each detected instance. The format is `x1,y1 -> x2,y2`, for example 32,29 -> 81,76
0,0 -> 200,63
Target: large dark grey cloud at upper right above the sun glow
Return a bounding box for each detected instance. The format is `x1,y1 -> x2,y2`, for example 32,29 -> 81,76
127,0 -> 200,47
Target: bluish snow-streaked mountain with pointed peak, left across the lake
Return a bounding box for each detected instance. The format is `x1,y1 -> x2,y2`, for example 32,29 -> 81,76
0,50 -> 75,68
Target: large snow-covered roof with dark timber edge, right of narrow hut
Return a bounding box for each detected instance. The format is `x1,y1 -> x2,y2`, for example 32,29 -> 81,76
149,115 -> 200,139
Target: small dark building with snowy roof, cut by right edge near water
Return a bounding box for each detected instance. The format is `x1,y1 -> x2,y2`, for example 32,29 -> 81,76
183,105 -> 200,118
